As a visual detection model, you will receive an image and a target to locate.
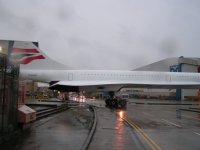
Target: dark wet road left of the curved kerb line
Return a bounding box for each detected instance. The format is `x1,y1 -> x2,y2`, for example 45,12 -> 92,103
1,108 -> 93,150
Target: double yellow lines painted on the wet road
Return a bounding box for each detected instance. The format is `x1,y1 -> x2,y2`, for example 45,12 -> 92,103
122,118 -> 161,150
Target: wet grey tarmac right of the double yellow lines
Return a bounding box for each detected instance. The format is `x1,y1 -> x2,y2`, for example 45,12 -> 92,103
124,103 -> 200,150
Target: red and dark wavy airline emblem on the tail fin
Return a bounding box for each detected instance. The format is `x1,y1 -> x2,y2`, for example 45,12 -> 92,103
11,48 -> 45,65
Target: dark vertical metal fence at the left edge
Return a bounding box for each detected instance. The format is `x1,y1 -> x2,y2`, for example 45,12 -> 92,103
0,54 -> 19,137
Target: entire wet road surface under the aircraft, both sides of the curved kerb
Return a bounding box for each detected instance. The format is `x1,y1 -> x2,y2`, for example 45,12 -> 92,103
1,101 -> 200,150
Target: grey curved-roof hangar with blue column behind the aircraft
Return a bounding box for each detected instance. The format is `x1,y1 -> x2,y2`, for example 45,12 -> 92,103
124,56 -> 200,100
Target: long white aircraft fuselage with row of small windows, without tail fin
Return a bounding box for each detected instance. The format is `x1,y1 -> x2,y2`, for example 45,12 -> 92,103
21,69 -> 200,87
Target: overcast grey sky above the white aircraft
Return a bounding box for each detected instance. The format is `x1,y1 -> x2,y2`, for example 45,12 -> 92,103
0,0 -> 200,70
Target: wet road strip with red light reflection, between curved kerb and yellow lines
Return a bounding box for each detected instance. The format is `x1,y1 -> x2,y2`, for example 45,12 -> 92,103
88,108 -> 141,150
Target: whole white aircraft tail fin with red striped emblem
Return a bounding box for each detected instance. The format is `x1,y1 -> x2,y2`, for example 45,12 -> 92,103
11,41 -> 70,70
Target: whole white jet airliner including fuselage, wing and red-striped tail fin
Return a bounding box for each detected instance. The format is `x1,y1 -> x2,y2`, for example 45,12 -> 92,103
11,41 -> 200,91
